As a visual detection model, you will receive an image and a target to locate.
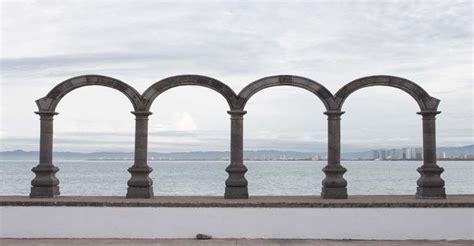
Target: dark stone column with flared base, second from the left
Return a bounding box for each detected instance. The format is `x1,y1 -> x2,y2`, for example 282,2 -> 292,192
127,111 -> 153,198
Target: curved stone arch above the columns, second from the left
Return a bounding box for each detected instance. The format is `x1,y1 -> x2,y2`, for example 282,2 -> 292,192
143,75 -> 237,111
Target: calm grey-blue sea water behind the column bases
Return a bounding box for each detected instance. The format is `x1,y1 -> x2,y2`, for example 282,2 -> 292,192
0,160 -> 474,196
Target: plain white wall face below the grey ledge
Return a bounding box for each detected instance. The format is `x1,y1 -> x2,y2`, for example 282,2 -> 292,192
0,207 -> 474,240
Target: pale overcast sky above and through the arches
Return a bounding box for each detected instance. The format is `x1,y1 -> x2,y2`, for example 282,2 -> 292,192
0,0 -> 474,152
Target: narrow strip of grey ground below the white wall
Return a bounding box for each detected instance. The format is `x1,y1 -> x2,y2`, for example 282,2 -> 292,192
0,239 -> 474,246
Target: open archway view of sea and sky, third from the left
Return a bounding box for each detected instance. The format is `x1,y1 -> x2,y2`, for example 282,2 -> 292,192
244,86 -> 327,196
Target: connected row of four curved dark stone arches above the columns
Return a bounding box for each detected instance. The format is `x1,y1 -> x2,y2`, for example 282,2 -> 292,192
36,75 -> 439,111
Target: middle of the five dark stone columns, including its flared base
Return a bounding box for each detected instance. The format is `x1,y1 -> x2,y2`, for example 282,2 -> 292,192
224,110 -> 249,199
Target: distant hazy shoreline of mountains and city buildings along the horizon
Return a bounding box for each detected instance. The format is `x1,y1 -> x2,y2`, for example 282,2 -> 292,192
0,145 -> 474,161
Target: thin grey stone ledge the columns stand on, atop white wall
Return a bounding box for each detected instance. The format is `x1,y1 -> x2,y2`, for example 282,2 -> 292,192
0,195 -> 474,208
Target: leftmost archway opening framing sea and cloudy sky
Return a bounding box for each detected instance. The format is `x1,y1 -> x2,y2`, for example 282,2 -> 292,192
53,86 -> 135,196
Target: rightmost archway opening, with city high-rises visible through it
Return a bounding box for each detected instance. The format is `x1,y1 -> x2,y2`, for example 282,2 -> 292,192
341,86 -> 423,195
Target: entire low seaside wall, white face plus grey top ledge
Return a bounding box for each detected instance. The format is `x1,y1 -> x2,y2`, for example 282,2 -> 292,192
0,195 -> 474,240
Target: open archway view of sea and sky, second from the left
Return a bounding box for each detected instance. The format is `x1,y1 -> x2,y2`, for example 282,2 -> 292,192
148,85 -> 230,196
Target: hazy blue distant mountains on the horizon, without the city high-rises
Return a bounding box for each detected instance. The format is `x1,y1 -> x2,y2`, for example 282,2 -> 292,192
0,145 -> 474,160
